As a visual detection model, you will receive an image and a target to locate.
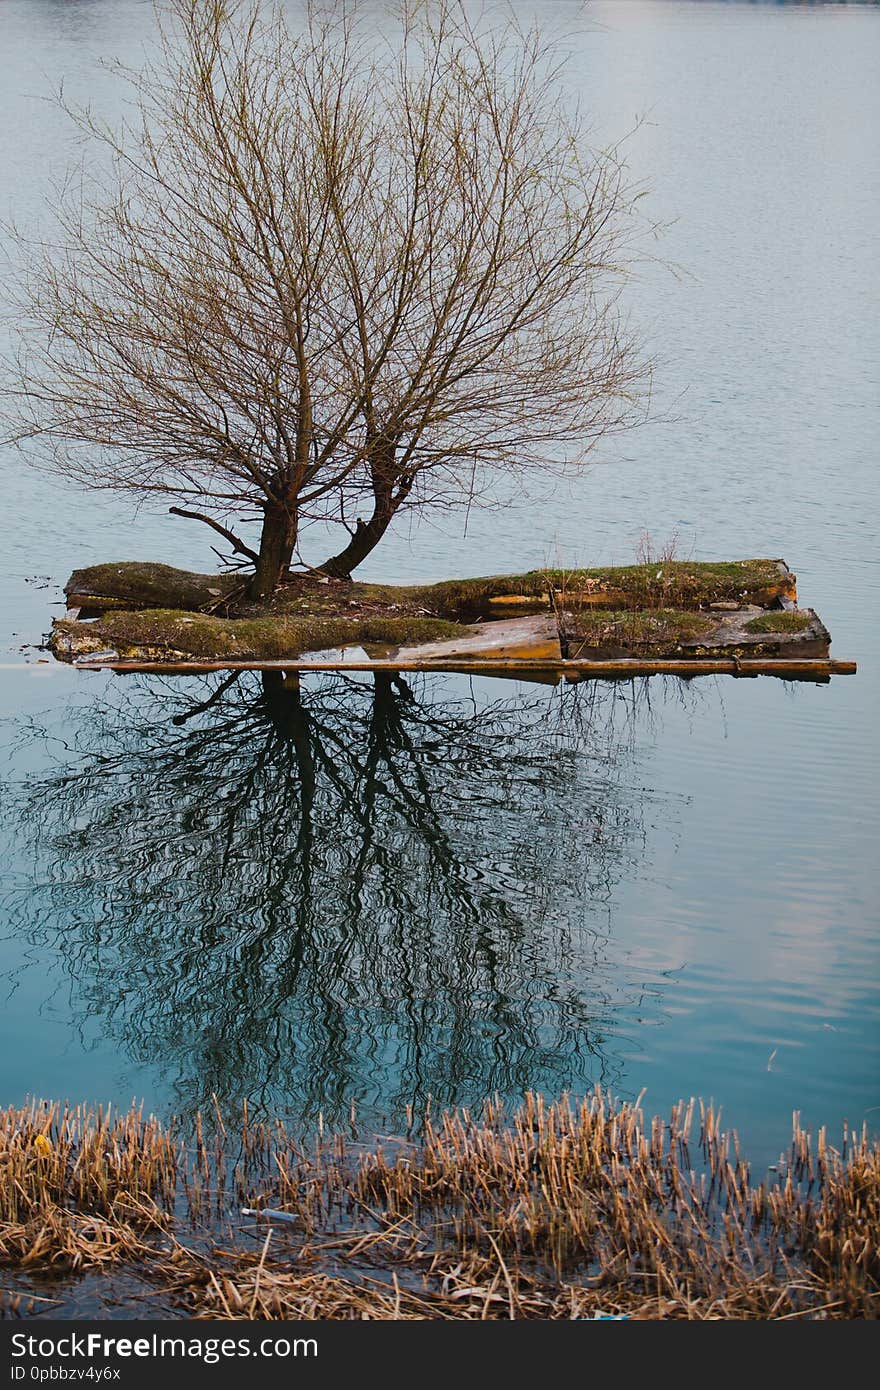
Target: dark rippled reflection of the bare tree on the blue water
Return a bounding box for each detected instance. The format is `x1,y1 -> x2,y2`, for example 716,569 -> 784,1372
1,673 -> 678,1125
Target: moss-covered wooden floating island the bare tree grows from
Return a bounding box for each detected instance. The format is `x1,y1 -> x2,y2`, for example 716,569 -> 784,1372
49,559 -> 855,680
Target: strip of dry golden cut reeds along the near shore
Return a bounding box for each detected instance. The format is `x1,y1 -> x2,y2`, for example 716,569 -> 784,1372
0,1088 -> 880,1319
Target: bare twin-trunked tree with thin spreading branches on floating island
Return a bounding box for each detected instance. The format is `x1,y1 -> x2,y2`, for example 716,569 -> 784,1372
3,0 -> 644,598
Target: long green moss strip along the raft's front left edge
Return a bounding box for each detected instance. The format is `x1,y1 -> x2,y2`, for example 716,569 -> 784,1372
53,609 -> 460,660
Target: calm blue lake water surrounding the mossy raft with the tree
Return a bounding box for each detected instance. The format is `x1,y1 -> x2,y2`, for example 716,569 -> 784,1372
0,0 -> 880,1166
